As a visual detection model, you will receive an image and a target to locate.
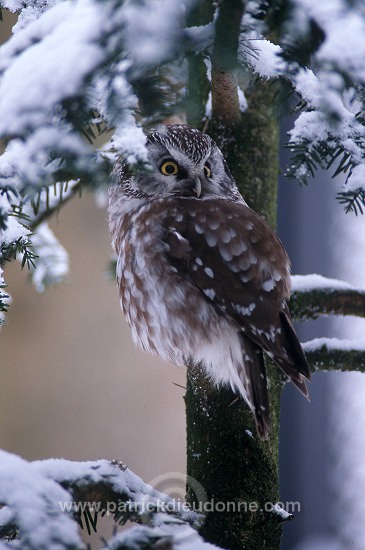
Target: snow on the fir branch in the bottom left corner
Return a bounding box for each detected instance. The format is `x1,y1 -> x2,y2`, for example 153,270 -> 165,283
0,451 -> 208,550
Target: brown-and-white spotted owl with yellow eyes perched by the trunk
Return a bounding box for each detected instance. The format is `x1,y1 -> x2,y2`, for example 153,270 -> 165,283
109,125 -> 310,439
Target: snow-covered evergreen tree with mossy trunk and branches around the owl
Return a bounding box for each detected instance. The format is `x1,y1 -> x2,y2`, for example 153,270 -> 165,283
0,0 -> 365,549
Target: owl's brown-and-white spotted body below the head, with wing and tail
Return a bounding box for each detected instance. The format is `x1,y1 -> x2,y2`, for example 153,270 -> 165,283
114,198 -> 310,438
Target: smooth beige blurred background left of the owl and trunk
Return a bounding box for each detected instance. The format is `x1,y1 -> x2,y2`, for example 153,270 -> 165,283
0,10 -> 185,481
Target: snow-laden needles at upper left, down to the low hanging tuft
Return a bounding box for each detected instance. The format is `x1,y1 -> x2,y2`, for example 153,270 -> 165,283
0,0 -> 151,322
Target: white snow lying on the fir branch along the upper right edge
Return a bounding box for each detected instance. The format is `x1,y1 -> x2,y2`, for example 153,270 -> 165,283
284,0 -> 365,191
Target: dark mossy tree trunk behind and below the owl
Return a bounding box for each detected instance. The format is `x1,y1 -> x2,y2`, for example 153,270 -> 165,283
186,0 -> 283,550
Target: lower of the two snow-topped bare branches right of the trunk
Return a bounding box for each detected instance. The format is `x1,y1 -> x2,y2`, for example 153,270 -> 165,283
303,338 -> 365,378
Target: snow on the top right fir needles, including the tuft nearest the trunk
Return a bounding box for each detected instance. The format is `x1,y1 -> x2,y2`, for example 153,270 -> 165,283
239,0 -> 365,191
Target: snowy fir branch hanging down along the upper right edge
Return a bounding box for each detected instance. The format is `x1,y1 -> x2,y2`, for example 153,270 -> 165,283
283,0 -> 365,212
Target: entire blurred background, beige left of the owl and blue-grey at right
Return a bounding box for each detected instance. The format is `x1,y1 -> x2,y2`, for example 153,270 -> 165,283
0,8 -> 365,550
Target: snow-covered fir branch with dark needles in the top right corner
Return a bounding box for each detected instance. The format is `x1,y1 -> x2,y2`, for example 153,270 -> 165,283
233,0 -> 365,213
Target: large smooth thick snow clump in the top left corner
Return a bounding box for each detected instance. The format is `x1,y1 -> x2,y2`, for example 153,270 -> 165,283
0,0 -> 104,135
